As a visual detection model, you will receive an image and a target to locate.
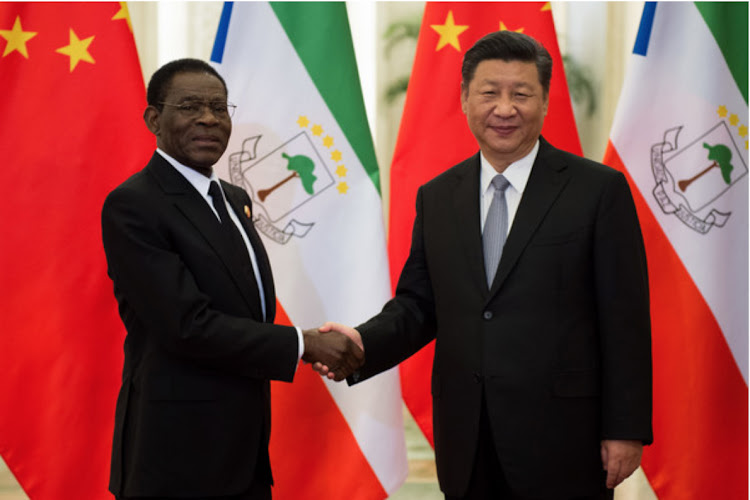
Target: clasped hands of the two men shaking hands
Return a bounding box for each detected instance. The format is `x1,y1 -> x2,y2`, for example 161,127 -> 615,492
302,322 -> 365,382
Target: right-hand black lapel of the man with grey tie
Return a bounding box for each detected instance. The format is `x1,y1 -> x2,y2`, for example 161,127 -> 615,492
490,138 -> 569,295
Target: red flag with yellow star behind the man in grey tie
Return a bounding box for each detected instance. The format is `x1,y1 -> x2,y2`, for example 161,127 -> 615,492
388,2 -> 581,443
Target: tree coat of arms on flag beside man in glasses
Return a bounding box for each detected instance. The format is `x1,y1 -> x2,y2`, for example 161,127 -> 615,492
229,118 -> 346,245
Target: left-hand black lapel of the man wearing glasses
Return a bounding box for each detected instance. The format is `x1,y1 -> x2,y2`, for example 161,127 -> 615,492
147,153 -> 262,318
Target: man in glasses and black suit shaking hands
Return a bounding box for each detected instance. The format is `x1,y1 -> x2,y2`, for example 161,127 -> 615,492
102,59 -> 362,500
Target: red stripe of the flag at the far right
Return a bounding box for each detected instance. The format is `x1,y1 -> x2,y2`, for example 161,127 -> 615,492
605,142 -> 748,500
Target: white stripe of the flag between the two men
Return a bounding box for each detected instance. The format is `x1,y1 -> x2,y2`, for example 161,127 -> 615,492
212,3 -> 407,493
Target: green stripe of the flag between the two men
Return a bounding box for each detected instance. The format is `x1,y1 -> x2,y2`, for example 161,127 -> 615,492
271,2 -> 380,193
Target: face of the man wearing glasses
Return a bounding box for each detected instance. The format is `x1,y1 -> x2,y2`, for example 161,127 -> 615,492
144,72 -> 232,176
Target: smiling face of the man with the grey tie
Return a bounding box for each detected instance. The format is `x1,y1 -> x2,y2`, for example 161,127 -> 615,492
461,59 -> 548,172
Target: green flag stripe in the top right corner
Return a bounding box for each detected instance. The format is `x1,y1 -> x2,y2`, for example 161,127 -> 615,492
686,2 -> 748,102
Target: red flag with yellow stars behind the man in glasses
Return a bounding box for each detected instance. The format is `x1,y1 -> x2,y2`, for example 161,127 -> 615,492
0,2 -> 154,500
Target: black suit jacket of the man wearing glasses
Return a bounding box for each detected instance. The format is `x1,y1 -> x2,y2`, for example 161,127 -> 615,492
102,153 -> 298,497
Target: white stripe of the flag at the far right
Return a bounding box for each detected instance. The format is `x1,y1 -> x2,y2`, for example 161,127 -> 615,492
612,2 -> 748,382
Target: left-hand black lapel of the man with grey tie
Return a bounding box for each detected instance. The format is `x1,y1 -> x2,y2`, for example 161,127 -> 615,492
454,153 -> 488,293
